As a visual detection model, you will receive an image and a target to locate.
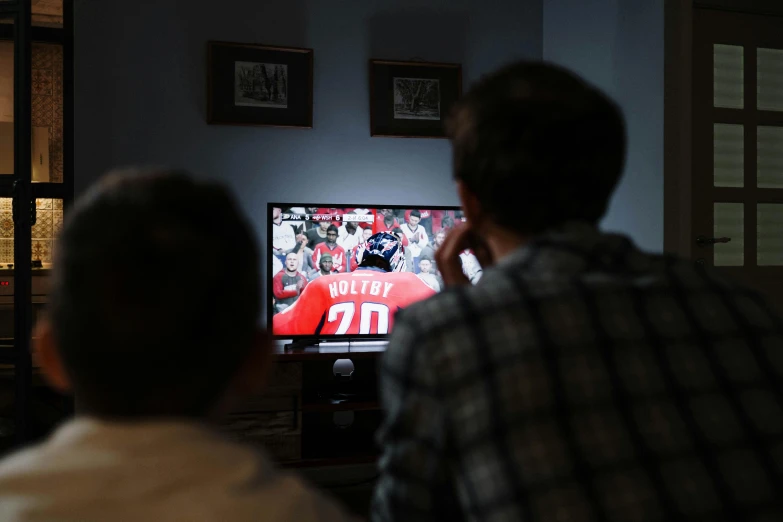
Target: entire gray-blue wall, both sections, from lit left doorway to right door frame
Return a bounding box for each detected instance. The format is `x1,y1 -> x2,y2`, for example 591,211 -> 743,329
75,0 -> 663,254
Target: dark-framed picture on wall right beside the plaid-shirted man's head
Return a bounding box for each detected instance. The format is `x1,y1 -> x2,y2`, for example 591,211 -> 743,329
370,60 -> 462,138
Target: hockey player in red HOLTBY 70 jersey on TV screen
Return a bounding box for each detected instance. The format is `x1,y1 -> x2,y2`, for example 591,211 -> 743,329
272,232 -> 435,336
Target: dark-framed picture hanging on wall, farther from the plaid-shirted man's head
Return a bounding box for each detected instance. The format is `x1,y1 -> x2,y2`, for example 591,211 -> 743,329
207,42 -> 313,128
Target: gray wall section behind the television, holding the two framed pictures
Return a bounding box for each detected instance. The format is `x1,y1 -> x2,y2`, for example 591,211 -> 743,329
75,0 -> 542,219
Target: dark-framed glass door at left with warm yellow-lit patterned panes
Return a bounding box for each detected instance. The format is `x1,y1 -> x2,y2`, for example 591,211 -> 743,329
0,0 -> 73,451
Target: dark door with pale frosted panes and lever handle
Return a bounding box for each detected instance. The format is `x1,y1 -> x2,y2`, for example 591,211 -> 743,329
692,9 -> 783,312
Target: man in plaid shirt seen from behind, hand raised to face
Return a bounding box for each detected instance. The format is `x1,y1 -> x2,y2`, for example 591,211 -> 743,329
372,63 -> 783,522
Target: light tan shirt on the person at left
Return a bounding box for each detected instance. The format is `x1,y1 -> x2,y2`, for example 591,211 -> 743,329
0,418 -> 349,522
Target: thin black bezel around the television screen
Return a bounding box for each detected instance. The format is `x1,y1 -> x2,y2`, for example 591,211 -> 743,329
264,202 -> 462,342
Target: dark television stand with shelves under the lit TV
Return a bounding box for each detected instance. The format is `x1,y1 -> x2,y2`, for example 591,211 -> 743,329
222,338 -> 385,468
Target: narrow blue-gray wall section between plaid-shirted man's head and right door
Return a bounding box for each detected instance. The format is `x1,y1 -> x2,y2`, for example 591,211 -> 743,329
543,0 -> 664,251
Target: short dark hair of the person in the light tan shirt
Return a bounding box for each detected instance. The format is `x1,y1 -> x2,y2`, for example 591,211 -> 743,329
49,171 -> 261,418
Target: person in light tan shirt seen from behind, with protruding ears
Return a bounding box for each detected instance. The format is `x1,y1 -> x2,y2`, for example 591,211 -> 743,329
0,171 -> 350,522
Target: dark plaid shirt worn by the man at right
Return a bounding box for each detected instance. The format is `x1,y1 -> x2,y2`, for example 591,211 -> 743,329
372,225 -> 783,522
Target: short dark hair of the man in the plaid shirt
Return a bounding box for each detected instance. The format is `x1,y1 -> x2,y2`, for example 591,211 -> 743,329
447,62 -> 626,234
